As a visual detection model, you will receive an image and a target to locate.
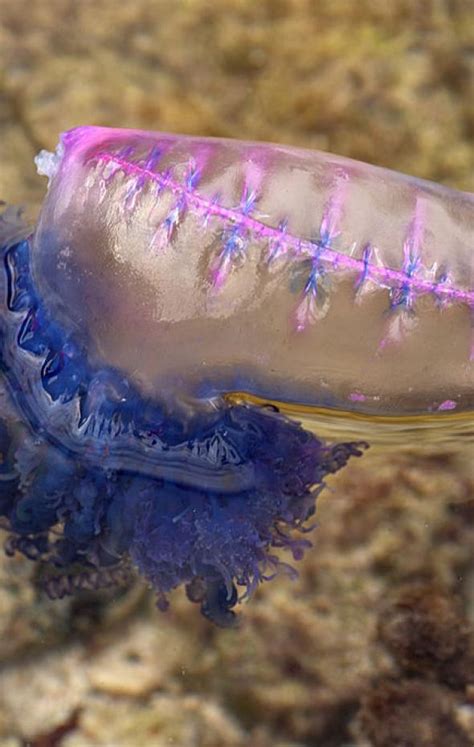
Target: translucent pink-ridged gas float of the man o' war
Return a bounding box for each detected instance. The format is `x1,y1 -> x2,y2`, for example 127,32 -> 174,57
34,127 -> 474,415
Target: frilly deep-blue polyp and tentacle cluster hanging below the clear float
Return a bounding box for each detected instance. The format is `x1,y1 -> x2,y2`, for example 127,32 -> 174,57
0,215 -> 364,625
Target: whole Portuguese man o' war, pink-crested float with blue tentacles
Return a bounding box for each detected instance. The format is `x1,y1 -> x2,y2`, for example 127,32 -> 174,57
0,127 -> 474,625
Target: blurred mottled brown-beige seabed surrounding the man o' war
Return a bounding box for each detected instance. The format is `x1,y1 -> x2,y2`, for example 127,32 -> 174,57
0,0 -> 474,747
